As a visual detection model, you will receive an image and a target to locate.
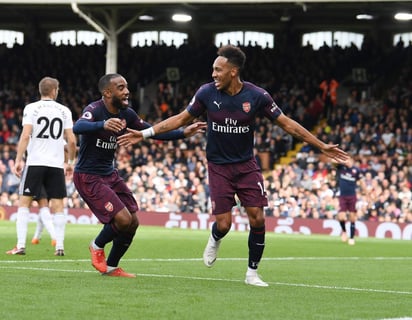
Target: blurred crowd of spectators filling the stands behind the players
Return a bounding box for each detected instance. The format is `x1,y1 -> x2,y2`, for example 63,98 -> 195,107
0,38 -> 412,223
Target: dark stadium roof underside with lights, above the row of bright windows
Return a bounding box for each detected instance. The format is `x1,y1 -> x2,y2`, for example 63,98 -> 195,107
0,0 -> 412,34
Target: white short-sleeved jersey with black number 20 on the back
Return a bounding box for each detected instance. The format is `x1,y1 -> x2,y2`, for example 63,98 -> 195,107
22,100 -> 73,168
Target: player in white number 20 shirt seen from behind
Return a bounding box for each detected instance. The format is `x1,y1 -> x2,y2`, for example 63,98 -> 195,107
6,77 -> 76,256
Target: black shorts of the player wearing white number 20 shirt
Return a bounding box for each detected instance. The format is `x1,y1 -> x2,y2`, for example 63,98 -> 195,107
19,166 -> 67,200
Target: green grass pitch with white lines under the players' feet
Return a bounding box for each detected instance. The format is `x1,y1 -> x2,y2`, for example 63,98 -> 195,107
0,221 -> 412,320
